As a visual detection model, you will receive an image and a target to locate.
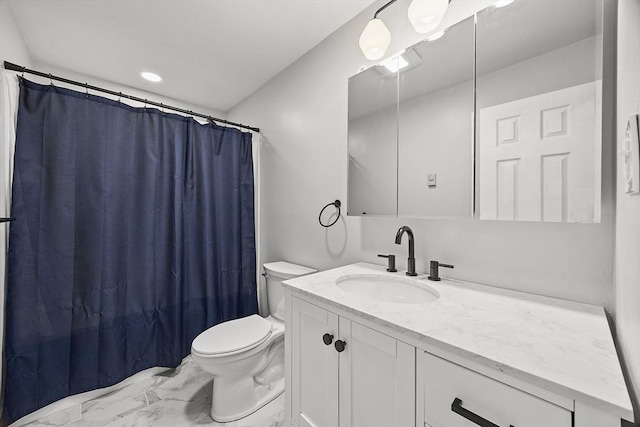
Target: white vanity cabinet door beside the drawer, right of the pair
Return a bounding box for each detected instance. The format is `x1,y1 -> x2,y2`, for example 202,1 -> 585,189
339,317 -> 416,427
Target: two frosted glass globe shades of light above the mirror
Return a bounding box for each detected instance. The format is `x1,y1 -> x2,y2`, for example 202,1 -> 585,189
359,0 -> 452,61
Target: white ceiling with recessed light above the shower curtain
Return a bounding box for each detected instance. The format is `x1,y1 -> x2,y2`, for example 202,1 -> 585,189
9,0 -> 374,112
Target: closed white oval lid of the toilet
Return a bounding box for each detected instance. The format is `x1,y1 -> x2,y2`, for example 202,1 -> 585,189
191,314 -> 271,355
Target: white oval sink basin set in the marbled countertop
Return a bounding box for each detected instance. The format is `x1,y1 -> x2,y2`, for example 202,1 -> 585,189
336,274 -> 440,304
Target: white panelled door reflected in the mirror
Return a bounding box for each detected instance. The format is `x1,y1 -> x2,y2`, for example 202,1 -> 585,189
478,82 -> 601,222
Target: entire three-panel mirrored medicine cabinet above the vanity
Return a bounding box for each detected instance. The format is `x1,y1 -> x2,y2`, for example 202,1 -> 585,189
347,0 -> 604,223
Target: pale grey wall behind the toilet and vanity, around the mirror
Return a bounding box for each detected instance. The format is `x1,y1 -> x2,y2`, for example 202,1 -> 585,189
229,0 -> 613,308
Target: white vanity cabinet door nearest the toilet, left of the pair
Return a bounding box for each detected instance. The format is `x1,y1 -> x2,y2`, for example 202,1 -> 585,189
288,298 -> 339,427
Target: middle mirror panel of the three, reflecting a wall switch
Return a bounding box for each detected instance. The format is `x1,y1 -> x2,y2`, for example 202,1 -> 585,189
398,17 -> 474,219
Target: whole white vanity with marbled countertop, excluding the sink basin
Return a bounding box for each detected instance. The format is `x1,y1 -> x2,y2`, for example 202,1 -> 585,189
284,263 -> 634,427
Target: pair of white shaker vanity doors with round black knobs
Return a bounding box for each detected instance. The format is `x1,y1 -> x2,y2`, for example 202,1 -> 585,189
287,296 -> 416,427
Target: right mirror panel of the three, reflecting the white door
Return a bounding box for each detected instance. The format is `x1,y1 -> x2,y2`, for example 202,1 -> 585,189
476,0 -> 603,223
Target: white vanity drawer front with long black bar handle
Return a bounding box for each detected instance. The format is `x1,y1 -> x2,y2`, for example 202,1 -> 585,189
418,352 -> 572,427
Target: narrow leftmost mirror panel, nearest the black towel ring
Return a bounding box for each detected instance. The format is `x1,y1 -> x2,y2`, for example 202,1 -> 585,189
347,59 -> 398,215
